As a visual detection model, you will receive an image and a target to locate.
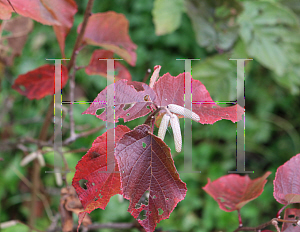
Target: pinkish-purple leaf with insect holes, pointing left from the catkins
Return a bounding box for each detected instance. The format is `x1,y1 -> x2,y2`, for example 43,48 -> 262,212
82,79 -> 156,122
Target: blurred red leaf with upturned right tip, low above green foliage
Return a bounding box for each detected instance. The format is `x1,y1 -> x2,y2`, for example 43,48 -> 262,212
203,172 -> 271,212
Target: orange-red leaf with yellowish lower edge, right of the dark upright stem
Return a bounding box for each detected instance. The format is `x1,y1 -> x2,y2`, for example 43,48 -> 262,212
77,11 -> 137,66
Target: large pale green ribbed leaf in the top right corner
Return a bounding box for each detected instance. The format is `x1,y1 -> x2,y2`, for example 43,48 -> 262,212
238,1 -> 299,76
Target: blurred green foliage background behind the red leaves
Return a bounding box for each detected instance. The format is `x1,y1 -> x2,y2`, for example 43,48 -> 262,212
0,0 -> 300,232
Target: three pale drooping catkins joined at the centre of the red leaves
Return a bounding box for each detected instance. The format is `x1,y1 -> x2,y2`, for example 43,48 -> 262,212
158,104 -> 200,152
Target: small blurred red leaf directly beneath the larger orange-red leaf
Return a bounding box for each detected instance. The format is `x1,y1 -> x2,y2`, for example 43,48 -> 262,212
85,50 -> 131,81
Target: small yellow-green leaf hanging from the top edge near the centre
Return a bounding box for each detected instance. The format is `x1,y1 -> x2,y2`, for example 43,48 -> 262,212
152,0 -> 184,35
